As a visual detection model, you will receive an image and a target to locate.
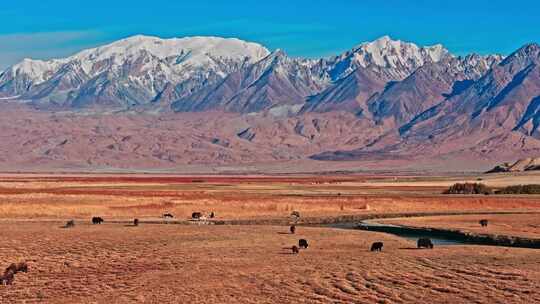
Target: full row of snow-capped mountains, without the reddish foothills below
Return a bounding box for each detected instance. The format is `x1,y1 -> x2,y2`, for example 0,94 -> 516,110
0,36 -> 516,119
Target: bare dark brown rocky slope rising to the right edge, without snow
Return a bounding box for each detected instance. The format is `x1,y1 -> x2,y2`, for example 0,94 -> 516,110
315,44 -> 540,164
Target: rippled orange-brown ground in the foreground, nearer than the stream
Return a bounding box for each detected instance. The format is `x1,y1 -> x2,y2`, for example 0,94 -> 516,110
0,223 -> 540,303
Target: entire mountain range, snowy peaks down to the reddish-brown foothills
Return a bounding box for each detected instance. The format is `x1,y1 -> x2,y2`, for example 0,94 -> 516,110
0,36 -> 540,170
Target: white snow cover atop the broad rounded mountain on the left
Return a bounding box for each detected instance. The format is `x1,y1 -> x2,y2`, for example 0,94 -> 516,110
1,35 -> 270,85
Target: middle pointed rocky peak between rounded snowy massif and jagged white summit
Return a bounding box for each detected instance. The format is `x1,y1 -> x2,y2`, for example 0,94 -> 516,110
173,50 -> 330,113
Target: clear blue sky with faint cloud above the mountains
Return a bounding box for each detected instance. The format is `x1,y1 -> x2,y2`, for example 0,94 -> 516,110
0,0 -> 540,68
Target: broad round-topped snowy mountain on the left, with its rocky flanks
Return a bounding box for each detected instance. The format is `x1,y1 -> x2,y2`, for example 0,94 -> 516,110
0,36 -> 269,107
